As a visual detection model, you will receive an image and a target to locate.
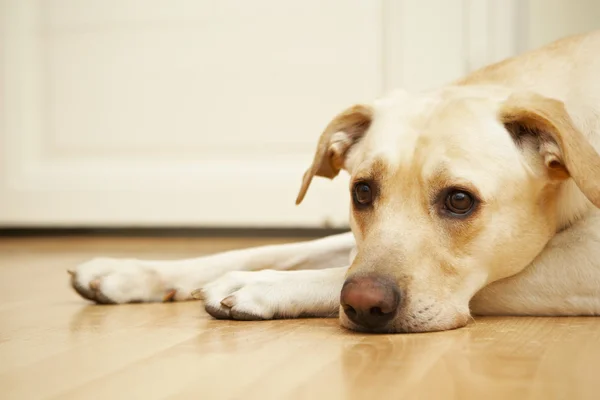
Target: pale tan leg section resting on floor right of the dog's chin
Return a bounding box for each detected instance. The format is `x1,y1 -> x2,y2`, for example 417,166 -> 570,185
471,211 -> 600,316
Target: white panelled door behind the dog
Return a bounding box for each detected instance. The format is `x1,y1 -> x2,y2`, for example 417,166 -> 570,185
0,0 -> 477,227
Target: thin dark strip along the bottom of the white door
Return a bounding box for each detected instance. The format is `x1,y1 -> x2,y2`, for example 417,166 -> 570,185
0,227 -> 350,238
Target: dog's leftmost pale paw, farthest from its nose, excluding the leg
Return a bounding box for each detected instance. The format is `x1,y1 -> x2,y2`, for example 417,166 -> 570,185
69,258 -> 177,304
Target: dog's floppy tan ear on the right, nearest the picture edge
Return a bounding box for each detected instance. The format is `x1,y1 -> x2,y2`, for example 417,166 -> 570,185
500,93 -> 600,208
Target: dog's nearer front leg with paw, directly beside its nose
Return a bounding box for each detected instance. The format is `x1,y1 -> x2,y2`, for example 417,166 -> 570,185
195,267 -> 348,320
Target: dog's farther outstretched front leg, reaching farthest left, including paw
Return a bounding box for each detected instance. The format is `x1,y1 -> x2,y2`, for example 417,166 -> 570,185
71,233 -> 354,304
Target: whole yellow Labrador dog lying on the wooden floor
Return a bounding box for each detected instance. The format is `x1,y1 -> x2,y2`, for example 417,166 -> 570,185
71,33 -> 600,332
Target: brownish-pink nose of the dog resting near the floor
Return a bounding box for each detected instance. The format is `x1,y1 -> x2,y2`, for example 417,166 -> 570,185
340,276 -> 401,328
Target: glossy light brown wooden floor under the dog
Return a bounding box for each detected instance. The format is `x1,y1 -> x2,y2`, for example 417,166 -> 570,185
0,238 -> 600,400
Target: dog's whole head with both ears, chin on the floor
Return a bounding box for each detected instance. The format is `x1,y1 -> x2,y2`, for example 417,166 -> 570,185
297,87 -> 600,332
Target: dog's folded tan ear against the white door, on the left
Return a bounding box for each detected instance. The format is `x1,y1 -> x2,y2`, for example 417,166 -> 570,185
296,105 -> 373,204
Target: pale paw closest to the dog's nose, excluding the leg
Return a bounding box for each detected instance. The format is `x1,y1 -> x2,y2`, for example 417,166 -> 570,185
193,270 -> 294,321
